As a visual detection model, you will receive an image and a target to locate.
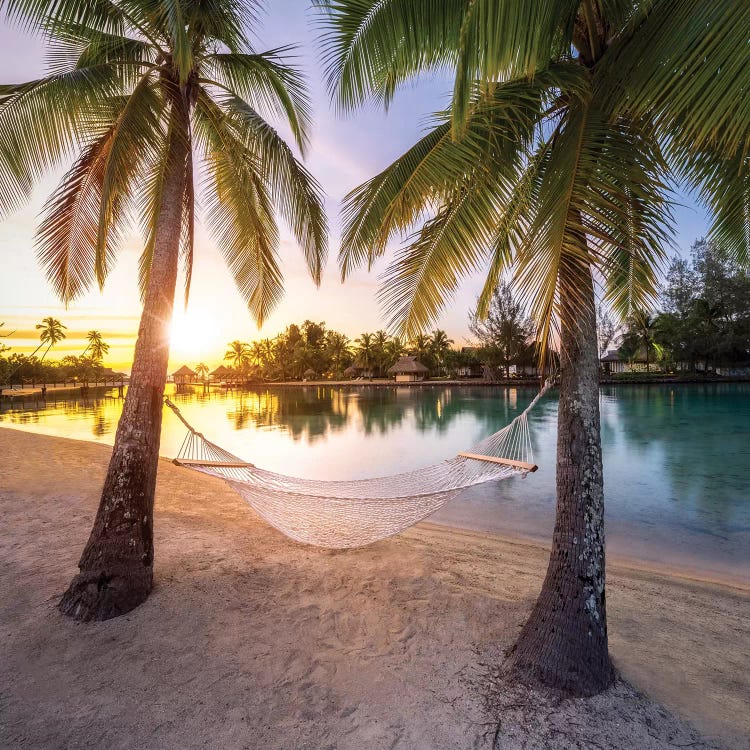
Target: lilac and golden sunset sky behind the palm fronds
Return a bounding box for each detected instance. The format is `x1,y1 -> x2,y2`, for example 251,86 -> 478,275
0,0 -> 708,371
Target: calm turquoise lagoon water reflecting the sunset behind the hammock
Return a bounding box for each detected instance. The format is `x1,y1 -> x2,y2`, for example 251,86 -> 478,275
0,383 -> 750,580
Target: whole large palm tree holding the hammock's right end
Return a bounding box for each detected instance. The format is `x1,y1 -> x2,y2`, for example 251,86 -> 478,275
317,0 -> 750,694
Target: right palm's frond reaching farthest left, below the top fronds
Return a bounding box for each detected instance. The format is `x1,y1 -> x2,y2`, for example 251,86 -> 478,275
339,65 -> 588,277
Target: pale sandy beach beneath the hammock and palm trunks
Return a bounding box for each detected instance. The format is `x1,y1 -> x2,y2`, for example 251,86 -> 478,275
0,429 -> 750,750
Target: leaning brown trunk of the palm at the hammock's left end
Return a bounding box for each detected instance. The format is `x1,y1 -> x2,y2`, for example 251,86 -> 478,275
60,106 -> 189,620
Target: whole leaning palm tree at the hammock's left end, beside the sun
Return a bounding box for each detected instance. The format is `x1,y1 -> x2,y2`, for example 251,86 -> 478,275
0,0 -> 327,620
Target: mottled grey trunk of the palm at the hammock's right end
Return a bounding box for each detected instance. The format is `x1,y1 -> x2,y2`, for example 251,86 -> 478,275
509,262 -> 614,695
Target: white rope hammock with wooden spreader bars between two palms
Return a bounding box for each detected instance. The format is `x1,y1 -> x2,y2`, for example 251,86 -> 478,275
164,378 -> 552,549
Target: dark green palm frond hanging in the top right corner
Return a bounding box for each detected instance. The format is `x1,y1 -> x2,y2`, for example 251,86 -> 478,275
599,0 -> 750,158
